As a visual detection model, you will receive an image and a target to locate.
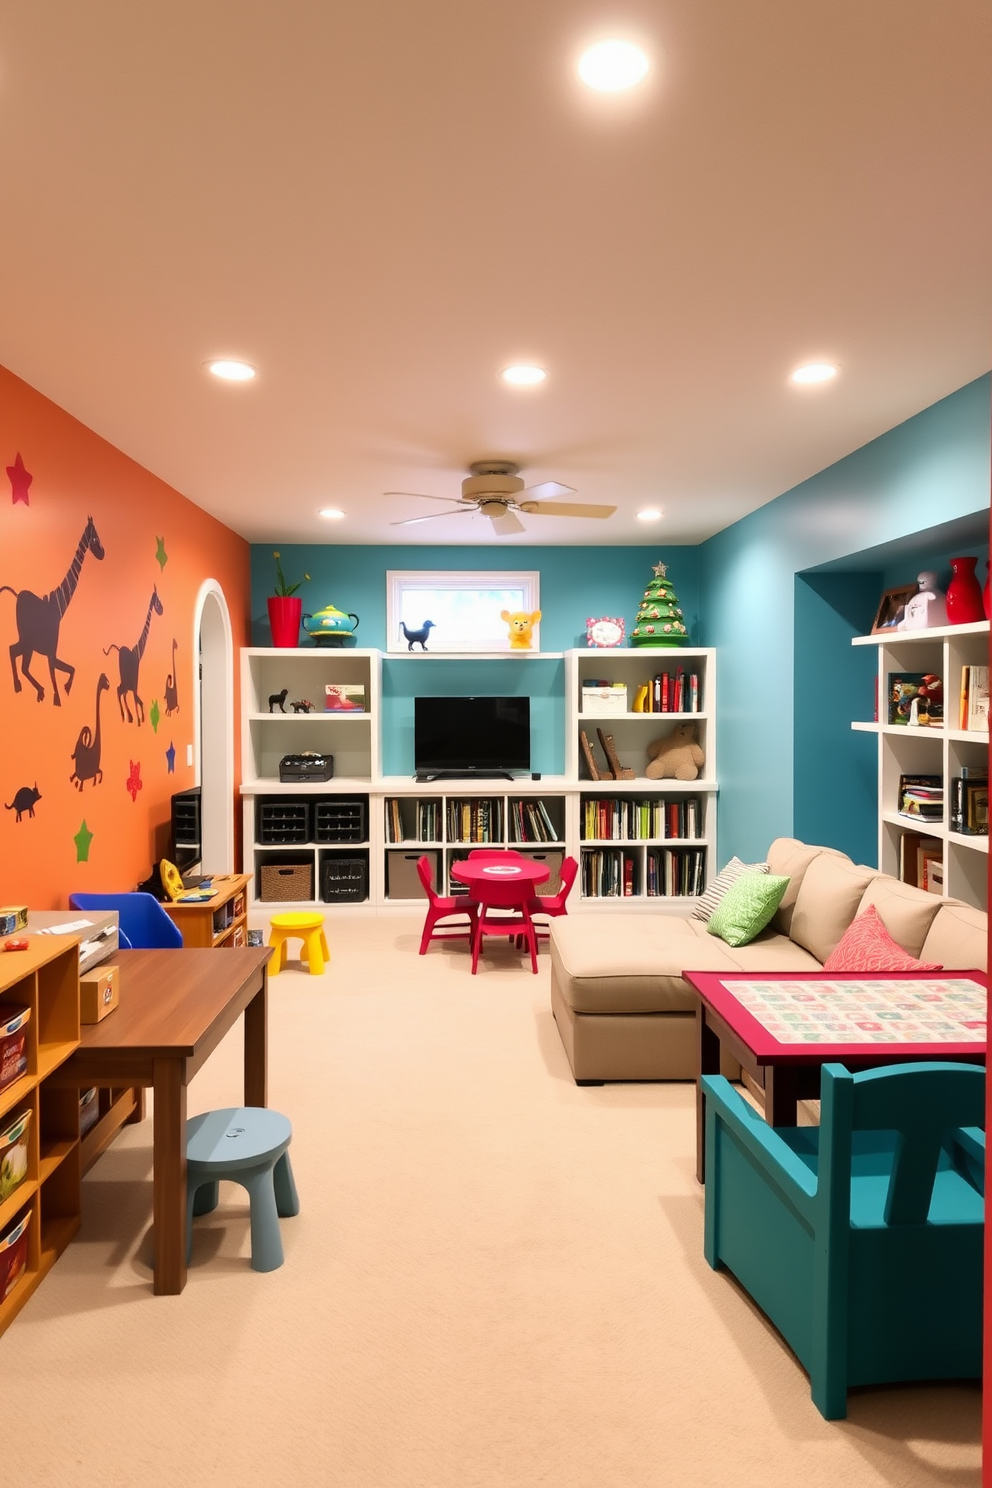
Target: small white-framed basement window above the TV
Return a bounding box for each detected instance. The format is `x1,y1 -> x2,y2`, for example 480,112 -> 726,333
385,568 -> 541,655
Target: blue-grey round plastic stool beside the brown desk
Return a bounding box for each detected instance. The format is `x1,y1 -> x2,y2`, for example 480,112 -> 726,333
186,1106 -> 299,1271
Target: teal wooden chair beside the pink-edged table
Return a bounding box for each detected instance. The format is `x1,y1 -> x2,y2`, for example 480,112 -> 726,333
702,1062 -> 985,1420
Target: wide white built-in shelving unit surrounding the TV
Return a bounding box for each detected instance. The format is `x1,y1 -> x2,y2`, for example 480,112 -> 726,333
241,647 -> 717,912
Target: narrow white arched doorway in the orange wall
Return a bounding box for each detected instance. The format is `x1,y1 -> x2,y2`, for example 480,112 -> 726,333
193,579 -> 235,873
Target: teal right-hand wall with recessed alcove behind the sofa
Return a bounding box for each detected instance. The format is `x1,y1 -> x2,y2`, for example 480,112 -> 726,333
699,375 -> 991,862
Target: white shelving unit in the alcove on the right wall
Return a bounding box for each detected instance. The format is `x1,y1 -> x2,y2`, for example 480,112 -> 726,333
851,620 -> 989,909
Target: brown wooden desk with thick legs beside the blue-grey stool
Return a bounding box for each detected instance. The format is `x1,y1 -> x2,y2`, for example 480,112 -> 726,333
49,946 -> 272,1295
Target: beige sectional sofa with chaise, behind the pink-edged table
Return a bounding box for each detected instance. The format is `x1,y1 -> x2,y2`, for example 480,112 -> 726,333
550,838 -> 988,1085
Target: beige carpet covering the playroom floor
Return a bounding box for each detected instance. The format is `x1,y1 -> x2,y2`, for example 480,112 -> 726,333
9,918 -> 980,1488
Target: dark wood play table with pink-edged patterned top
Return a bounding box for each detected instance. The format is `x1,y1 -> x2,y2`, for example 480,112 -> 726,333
683,972 -> 989,1183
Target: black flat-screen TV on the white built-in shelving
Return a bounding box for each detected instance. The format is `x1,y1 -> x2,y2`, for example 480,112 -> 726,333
413,698 -> 531,778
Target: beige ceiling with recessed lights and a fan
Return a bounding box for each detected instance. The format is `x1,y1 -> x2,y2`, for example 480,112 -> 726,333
0,0 -> 992,546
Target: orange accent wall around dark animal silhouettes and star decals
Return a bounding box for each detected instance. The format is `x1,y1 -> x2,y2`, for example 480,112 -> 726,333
0,368 -> 250,909
